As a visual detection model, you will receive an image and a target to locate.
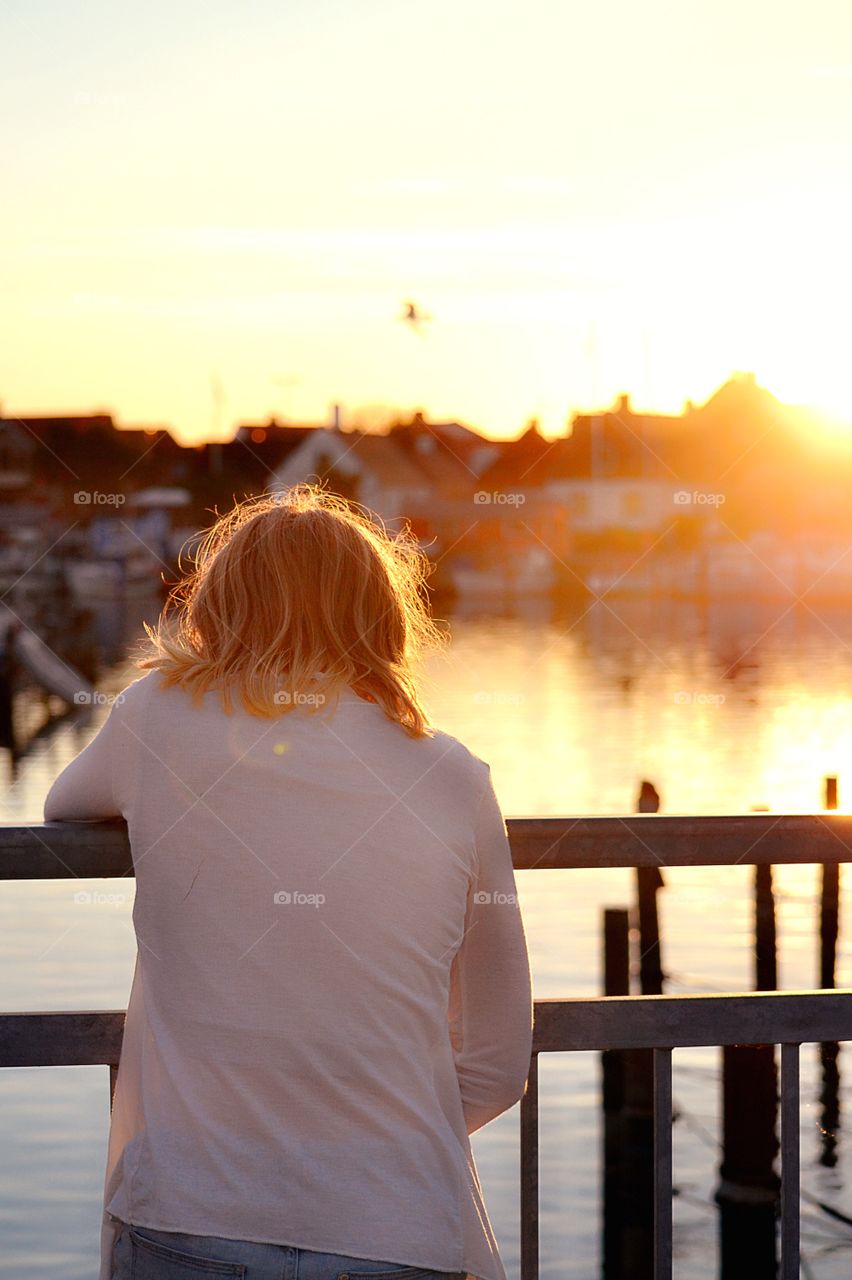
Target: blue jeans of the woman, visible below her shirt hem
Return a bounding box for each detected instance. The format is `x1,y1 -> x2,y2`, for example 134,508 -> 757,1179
111,1222 -> 467,1280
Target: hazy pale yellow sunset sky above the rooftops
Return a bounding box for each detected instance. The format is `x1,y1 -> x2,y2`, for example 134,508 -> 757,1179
0,0 -> 852,439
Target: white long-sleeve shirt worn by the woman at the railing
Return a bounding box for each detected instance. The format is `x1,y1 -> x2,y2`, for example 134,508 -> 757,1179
45,672 -> 532,1280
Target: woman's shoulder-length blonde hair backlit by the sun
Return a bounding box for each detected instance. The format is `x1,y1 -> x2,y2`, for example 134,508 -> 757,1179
136,484 -> 445,737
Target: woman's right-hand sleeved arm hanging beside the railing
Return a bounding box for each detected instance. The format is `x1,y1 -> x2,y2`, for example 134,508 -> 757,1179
450,772 -> 532,1134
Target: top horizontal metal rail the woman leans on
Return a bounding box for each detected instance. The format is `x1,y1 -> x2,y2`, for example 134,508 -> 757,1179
0,812 -> 852,879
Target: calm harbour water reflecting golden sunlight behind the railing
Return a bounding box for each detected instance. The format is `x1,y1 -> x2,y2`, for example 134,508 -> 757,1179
0,600 -> 852,1280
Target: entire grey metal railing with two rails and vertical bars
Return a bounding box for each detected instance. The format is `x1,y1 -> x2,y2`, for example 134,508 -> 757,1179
0,813 -> 852,1280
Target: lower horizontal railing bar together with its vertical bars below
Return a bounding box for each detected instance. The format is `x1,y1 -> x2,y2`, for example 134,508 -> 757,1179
0,991 -> 852,1280
